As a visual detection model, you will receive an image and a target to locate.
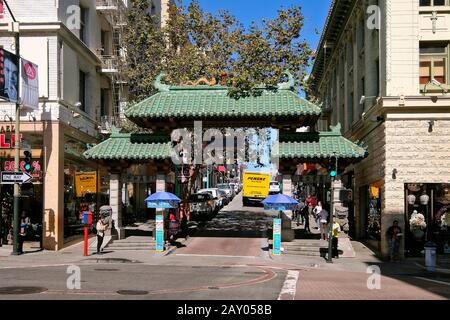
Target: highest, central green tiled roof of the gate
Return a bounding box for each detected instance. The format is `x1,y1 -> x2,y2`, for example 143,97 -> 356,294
125,85 -> 321,119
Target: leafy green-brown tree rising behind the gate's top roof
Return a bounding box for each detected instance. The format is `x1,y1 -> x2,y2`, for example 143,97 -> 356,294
124,0 -> 312,100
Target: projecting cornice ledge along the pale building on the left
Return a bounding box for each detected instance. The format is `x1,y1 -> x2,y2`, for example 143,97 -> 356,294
0,21 -> 101,66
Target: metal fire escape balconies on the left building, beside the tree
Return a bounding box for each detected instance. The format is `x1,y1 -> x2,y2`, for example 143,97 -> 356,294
96,0 -> 127,134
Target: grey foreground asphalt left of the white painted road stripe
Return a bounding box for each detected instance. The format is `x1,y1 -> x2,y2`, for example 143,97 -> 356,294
0,263 -> 285,300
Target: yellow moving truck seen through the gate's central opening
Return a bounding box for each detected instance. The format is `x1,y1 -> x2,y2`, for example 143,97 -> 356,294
242,171 -> 270,206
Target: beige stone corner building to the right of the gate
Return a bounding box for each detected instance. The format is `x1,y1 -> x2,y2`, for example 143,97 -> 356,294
311,0 -> 450,256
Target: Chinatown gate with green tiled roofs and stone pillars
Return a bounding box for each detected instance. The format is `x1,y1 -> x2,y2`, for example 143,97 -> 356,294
84,73 -> 367,241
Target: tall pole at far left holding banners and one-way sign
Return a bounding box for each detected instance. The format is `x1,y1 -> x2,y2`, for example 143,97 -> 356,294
4,0 -> 22,255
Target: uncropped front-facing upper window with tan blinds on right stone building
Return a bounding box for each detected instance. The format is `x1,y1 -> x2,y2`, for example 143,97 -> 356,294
420,43 -> 448,84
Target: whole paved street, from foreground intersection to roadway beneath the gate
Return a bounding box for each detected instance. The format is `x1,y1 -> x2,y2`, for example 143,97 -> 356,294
0,195 -> 450,300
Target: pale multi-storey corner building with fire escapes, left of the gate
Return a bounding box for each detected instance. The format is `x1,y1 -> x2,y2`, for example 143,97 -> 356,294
0,0 -> 166,250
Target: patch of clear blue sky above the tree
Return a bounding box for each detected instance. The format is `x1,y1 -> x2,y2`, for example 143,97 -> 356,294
183,0 -> 331,55
